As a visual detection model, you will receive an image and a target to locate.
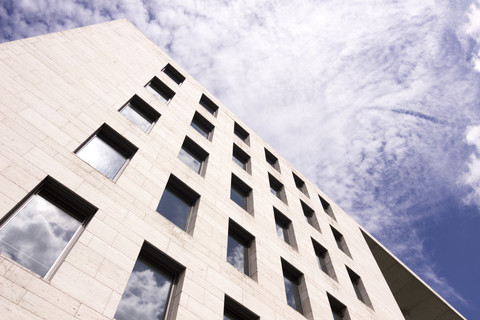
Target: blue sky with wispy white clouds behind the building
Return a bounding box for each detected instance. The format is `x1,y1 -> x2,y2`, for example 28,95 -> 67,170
0,0 -> 480,319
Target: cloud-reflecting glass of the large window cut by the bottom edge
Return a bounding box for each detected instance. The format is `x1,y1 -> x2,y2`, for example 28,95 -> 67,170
115,260 -> 173,320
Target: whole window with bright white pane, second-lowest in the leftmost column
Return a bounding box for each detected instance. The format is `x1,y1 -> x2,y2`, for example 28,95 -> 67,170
75,124 -> 138,181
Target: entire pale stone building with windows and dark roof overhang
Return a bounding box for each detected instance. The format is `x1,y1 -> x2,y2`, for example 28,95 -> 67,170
0,20 -> 464,320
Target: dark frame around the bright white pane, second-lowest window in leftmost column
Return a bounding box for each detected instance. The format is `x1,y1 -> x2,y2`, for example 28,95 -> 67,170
74,123 -> 138,182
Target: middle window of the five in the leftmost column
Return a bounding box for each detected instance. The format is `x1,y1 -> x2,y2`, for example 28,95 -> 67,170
118,95 -> 160,132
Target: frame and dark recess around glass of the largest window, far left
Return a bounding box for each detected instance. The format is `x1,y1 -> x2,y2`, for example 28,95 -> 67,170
0,176 -> 98,281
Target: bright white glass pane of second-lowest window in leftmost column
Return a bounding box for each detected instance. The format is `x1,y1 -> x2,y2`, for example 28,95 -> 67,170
77,137 -> 127,180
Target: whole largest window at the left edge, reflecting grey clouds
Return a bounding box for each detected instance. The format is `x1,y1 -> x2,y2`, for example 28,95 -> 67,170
0,177 -> 97,279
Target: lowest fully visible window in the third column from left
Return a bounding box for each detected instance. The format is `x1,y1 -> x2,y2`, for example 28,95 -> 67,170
227,219 -> 256,277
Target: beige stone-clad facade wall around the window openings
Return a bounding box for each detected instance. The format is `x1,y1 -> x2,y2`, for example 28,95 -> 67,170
0,20 -> 403,320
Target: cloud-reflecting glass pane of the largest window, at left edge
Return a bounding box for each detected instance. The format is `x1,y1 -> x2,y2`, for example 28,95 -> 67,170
0,195 -> 81,277
